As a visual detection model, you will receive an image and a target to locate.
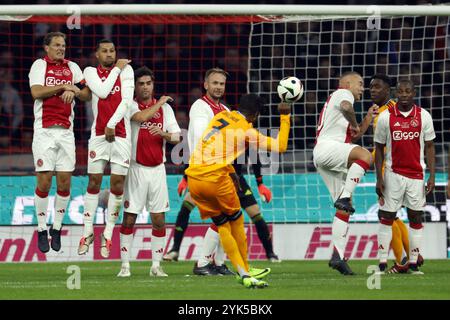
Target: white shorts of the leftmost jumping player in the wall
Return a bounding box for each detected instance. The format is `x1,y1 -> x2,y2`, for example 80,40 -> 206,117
32,128 -> 75,172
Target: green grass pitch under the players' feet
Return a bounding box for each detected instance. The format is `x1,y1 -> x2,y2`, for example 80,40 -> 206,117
0,259 -> 450,300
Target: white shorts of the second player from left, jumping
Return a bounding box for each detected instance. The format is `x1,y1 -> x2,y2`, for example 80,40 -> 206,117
88,136 -> 131,176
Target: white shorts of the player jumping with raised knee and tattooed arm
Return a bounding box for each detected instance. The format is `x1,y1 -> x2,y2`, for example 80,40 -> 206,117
313,141 -> 358,202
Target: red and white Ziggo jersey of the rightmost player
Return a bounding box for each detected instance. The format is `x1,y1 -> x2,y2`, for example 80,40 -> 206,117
374,104 -> 436,179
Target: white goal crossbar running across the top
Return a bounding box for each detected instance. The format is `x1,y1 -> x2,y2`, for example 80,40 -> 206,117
0,4 -> 450,16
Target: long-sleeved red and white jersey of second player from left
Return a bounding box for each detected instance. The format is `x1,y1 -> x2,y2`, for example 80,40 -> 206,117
84,65 -> 134,138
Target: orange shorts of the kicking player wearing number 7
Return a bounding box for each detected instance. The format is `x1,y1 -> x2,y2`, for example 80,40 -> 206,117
188,176 -> 241,220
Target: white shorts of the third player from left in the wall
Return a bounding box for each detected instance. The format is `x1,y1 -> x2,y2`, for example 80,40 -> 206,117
123,162 -> 170,214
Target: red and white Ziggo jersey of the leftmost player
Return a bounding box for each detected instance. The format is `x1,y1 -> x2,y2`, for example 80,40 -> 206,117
28,56 -> 84,130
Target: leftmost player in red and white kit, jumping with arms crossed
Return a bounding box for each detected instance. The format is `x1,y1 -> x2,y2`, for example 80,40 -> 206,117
29,32 -> 91,253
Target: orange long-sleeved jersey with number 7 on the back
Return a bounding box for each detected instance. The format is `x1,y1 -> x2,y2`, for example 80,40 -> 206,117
185,111 -> 290,182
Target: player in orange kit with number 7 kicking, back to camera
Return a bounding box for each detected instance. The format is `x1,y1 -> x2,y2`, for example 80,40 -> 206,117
185,94 -> 290,288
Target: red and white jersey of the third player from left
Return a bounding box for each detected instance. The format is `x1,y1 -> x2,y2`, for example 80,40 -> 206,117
129,99 -> 181,167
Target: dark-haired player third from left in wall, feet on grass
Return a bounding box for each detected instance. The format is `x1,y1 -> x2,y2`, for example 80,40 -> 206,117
108,67 -> 181,277
